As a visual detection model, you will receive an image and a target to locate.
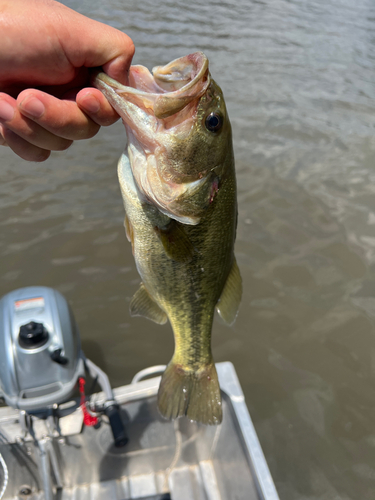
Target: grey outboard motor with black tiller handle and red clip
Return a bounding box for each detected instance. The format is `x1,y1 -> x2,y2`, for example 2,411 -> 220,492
0,286 -> 128,500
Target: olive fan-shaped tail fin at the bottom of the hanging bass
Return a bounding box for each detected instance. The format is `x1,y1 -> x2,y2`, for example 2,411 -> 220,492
158,360 -> 222,425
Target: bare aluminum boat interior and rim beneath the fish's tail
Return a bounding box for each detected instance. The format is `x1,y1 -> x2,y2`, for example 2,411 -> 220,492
0,362 -> 279,500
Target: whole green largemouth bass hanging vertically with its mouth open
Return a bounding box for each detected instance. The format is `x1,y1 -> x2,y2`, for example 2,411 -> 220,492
93,52 -> 242,424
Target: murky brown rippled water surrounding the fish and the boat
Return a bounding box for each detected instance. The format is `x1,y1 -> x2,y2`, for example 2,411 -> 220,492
0,0 -> 375,500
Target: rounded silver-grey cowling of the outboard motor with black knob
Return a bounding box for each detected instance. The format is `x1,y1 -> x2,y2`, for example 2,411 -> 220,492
0,286 -> 84,412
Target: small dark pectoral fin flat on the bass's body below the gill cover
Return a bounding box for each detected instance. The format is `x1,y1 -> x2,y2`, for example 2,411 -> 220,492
154,220 -> 194,262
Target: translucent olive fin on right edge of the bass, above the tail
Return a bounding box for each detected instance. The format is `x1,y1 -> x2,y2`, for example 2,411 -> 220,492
216,259 -> 242,325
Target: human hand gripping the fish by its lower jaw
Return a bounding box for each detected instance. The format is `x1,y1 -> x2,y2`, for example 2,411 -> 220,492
0,0 -> 134,161
